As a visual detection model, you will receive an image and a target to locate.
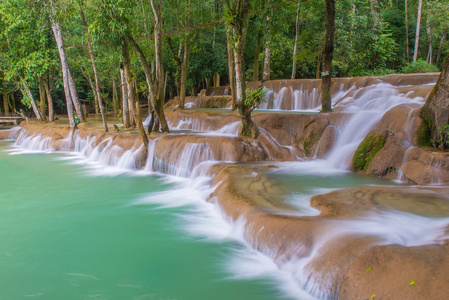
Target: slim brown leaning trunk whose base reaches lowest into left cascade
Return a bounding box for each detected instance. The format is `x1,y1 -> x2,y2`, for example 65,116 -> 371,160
122,39 -> 148,159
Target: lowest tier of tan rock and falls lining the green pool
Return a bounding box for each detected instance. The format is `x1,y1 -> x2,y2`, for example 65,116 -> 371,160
1,117 -> 449,299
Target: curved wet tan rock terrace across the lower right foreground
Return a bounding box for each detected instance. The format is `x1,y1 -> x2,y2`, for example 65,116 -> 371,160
210,166 -> 449,299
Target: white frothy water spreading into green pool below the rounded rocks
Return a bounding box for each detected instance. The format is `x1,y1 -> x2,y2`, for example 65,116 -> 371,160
134,177 -> 315,300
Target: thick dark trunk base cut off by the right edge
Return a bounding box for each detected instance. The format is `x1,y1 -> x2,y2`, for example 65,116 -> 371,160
420,56 -> 449,148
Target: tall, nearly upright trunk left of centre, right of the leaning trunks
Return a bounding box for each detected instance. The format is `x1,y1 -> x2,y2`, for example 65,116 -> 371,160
151,0 -> 170,132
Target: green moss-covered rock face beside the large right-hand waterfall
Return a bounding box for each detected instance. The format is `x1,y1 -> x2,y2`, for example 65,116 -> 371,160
352,132 -> 387,171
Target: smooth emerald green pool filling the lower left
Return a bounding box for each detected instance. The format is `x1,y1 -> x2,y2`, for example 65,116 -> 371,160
0,142 -> 297,300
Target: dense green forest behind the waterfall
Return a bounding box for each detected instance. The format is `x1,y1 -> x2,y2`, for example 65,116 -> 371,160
0,0 -> 449,118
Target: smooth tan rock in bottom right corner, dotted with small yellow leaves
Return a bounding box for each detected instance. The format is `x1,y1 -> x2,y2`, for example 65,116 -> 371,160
340,241 -> 449,300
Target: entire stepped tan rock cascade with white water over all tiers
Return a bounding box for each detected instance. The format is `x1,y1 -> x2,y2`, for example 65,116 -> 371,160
0,74 -> 449,299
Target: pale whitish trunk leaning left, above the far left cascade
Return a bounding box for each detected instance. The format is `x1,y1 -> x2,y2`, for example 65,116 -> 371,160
52,19 -> 76,130
